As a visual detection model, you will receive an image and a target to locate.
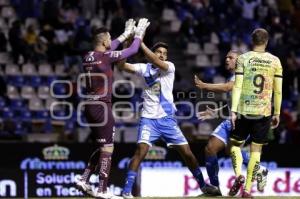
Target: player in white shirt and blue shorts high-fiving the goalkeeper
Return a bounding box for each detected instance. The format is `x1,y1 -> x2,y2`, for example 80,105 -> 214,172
118,42 -> 218,198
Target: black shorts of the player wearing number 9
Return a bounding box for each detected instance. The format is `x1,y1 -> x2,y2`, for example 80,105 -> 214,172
230,115 -> 271,144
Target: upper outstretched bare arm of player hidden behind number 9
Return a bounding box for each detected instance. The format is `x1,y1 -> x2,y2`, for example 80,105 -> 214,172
194,75 -> 234,93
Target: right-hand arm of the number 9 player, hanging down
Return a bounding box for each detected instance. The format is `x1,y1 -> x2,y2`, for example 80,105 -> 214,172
272,57 -> 282,128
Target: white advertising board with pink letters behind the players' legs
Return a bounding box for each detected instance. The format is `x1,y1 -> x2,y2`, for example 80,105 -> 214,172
141,168 -> 300,197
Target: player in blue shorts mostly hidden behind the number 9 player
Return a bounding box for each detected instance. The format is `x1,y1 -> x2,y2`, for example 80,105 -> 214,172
195,50 -> 268,195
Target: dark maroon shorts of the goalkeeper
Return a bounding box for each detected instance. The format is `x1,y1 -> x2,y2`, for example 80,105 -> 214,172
84,102 -> 115,146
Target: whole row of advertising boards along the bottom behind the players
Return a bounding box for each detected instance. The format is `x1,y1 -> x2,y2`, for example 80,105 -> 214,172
0,143 -> 300,198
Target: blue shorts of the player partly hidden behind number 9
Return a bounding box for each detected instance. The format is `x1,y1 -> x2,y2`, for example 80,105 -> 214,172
211,120 -> 232,145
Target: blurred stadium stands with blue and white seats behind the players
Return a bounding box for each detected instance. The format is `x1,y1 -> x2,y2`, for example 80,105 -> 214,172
0,0 -> 300,143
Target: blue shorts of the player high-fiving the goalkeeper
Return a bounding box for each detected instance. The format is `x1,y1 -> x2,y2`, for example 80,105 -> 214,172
137,116 -> 188,146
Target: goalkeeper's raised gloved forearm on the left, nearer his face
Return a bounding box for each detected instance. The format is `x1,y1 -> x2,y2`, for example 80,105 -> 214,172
111,19 -> 135,50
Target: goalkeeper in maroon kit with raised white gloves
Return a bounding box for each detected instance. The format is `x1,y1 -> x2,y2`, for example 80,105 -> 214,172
76,18 -> 150,199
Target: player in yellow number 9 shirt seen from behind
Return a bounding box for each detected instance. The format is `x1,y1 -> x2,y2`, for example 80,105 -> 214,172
229,29 -> 282,197
